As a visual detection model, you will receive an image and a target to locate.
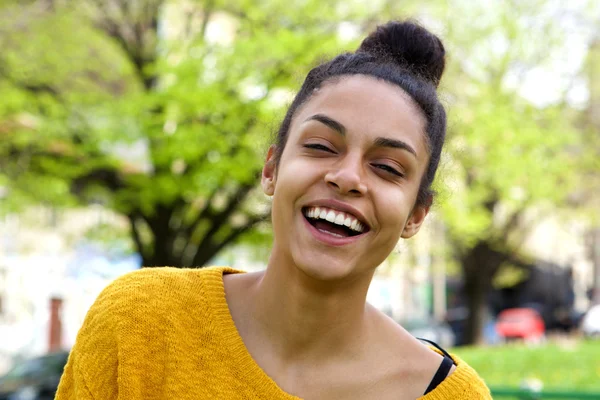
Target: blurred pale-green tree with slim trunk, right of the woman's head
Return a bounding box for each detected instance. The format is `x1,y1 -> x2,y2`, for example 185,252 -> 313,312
432,2 -> 582,343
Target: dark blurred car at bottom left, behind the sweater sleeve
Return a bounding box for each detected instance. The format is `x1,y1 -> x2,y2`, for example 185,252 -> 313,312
0,351 -> 69,400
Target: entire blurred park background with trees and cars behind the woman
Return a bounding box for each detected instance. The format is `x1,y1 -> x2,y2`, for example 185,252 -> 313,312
0,0 -> 600,400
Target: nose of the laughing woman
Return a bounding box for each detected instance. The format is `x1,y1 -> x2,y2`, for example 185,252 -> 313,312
325,156 -> 367,196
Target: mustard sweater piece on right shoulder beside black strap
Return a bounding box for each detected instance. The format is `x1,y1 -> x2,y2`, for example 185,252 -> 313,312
420,349 -> 492,400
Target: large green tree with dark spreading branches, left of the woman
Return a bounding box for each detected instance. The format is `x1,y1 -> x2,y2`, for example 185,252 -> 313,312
0,0 -> 352,266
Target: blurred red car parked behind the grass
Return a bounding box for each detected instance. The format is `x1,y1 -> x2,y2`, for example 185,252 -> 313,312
496,308 -> 546,342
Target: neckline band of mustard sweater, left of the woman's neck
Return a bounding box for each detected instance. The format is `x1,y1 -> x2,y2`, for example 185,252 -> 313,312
206,267 -> 302,400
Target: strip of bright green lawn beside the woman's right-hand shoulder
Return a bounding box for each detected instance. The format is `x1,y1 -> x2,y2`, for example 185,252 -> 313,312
452,340 -> 600,393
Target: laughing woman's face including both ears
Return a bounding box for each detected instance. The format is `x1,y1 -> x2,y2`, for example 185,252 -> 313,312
262,75 -> 429,280
